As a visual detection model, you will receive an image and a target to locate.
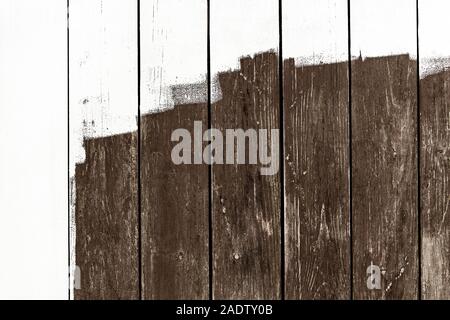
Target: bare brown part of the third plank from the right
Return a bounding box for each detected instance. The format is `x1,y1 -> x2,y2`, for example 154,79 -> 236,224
283,59 -> 351,299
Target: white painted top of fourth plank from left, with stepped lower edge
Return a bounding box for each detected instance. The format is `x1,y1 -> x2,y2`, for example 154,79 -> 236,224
210,0 -> 279,102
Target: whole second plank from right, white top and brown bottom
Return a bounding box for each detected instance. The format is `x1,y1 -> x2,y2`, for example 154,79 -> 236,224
351,0 -> 418,299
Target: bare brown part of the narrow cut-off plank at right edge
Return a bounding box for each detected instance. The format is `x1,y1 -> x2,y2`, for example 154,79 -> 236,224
420,71 -> 450,299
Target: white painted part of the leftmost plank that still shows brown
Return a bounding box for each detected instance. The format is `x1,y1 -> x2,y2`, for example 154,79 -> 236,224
69,0 -> 138,293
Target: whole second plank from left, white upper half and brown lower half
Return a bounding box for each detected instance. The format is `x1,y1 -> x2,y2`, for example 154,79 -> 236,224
69,0 -> 139,299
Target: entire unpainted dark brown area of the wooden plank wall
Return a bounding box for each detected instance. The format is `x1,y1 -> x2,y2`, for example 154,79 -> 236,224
69,0 -> 450,299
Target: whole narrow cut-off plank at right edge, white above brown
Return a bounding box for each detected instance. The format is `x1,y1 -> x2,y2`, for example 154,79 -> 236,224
419,0 -> 450,299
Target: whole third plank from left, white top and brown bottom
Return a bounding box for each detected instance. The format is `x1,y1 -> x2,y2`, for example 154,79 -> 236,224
140,0 -> 209,299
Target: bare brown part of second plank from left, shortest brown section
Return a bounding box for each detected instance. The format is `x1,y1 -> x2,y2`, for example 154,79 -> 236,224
74,133 -> 139,300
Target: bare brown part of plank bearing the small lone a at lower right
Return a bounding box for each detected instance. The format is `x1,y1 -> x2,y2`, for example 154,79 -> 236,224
351,55 -> 418,299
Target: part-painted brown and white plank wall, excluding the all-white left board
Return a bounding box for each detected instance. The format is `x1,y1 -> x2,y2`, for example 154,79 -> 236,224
61,0 -> 450,299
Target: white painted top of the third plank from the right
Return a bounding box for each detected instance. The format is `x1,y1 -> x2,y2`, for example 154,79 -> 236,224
282,0 -> 348,65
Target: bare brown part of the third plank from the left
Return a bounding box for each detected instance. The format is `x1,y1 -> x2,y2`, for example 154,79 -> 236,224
141,103 -> 209,299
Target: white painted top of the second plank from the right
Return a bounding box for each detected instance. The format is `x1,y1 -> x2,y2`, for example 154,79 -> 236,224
350,0 -> 417,57
